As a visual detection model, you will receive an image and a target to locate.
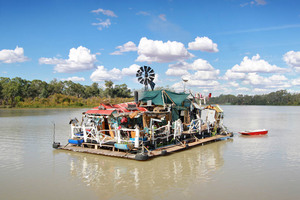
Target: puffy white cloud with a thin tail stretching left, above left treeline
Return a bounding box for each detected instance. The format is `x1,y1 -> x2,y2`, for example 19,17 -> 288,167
39,46 -> 97,73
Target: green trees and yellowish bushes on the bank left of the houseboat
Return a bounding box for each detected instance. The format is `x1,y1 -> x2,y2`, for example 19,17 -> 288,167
0,77 -> 133,108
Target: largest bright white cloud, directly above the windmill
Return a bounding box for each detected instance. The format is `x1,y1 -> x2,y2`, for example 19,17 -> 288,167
136,37 -> 194,63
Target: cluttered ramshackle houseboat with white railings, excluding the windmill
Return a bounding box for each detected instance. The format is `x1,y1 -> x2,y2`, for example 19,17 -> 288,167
53,90 -> 233,160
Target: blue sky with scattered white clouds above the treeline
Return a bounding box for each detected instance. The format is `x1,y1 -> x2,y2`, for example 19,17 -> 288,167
0,0 -> 300,96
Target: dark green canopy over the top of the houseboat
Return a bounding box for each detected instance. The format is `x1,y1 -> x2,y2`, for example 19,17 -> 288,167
140,90 -> 189,106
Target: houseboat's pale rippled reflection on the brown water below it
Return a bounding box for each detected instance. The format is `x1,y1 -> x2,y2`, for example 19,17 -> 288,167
54,141 -> 227,198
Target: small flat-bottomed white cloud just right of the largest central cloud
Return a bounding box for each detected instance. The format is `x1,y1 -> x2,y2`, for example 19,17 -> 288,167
188,37 -> 219,52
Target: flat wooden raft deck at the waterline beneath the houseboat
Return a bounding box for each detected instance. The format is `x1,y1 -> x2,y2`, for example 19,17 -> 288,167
57,133 -> 232,160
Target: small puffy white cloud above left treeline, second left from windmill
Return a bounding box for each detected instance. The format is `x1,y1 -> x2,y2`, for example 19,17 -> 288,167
90,66 -> 122,82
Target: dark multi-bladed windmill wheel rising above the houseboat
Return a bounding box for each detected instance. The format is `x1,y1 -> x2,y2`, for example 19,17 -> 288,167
136,66 -> 155,91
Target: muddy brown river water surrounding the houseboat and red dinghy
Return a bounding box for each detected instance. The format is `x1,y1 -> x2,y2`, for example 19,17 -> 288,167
0,106 -> 300,200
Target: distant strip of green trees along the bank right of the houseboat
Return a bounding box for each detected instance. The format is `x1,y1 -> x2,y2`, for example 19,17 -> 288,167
209,90 -> 300,105
